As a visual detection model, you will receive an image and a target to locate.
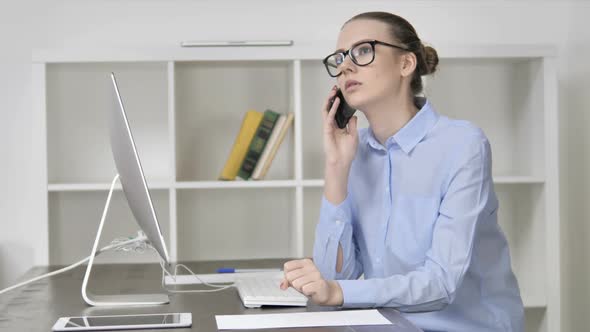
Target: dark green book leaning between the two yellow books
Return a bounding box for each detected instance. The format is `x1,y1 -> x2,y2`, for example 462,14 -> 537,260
238,110 -> 280,180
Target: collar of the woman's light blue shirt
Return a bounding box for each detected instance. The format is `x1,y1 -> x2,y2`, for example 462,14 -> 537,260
367,97 -> 439,154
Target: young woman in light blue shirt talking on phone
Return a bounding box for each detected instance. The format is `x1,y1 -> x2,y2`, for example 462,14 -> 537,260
281,12 -> 524,332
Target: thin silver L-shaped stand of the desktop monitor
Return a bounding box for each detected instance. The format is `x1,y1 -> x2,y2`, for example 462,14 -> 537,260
82,174 -> 170,307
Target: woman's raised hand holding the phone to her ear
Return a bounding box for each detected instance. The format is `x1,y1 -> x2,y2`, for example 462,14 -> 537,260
322,86 -> 358,170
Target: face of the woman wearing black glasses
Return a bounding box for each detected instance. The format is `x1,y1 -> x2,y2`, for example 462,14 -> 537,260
336,19 -> 410,110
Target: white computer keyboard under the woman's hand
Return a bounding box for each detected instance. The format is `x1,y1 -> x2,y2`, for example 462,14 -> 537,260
235,277 -> 307,308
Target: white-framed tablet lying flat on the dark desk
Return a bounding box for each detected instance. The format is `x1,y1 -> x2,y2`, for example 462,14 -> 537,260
52,313 -> 192,331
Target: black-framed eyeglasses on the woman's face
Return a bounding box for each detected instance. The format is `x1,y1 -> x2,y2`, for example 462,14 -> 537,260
322,40 -> 410,77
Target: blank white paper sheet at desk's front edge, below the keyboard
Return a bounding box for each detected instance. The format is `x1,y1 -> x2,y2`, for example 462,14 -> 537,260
215,309 -> 392,330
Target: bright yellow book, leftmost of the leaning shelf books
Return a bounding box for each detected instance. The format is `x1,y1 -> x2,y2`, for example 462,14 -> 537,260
219,111 -> 263,180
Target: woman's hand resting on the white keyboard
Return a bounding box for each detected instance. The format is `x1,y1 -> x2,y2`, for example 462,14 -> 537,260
281,258 -> 343,306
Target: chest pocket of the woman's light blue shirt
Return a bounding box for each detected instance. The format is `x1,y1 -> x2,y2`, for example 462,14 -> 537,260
386,193 -> 440,267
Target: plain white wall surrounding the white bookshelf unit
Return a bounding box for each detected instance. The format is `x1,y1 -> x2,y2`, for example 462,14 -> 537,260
0,0 -> 590,331
